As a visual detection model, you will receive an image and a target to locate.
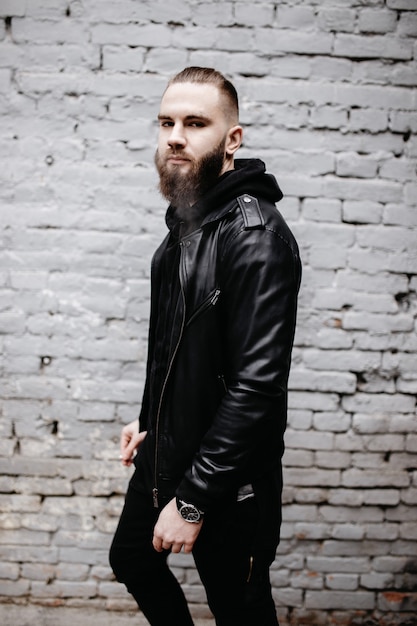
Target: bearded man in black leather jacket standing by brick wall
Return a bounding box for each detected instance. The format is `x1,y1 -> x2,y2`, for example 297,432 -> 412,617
110,67 -> 301,626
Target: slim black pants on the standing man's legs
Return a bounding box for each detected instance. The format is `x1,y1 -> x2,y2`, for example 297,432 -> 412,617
110,486 -> 278,626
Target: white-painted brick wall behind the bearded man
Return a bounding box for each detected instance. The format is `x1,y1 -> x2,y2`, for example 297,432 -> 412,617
0,0 -> 417,625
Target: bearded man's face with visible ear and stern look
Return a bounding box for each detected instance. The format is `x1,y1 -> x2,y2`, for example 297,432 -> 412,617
155,83 -> 242,206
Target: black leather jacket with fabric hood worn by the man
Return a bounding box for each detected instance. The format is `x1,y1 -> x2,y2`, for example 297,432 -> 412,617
135,160 -> 301,511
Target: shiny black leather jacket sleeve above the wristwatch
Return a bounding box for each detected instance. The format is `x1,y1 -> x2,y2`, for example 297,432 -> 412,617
177,217 -> 300,510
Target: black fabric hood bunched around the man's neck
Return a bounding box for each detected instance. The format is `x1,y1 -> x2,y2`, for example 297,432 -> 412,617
166,159 -> 283,230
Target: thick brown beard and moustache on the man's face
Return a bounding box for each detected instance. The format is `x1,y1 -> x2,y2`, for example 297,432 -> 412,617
155,139 -> 226,213
